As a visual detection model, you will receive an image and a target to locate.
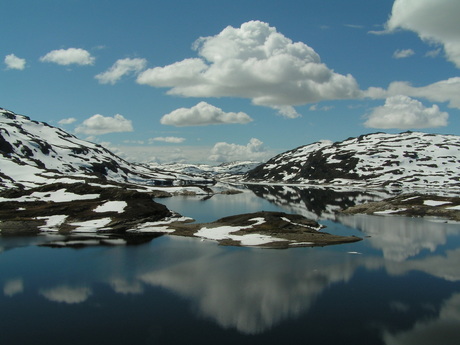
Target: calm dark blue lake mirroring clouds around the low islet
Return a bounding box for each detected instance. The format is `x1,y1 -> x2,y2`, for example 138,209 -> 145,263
0,186 -> 460,345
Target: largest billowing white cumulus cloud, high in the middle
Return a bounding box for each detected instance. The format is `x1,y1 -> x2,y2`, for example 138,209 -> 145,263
137,21 -> 360,117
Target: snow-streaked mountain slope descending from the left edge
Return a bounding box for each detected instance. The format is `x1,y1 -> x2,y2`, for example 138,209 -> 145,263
0,108 -> 210,189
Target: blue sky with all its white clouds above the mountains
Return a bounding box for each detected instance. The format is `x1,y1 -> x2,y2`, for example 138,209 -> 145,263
0,0 -> 460,165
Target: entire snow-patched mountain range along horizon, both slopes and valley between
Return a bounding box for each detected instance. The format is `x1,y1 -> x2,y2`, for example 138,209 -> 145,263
0,108 -> 460,191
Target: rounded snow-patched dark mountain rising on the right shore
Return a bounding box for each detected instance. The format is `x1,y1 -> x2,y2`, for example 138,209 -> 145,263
245,132 -> 460,190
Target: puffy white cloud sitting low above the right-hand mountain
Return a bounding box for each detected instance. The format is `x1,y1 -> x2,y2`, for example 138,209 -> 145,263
364,95 -> 449,129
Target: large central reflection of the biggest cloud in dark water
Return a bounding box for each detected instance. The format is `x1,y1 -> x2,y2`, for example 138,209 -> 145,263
140,242 -> 359,334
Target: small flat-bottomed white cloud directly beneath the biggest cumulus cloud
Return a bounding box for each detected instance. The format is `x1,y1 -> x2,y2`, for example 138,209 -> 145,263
160,102 -> 252,127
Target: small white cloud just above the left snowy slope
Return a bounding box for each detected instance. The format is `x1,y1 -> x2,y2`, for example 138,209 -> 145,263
75,114 -> 133,135
